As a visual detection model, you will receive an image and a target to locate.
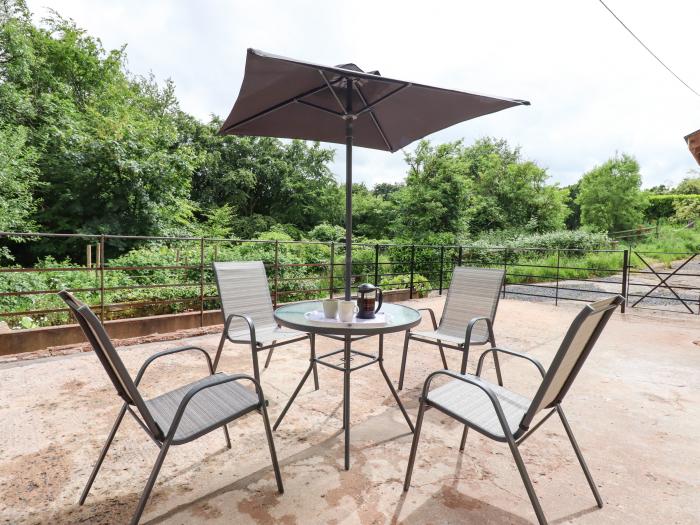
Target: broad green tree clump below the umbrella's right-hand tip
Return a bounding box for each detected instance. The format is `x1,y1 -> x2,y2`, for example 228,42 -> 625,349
394,138 -> 569,237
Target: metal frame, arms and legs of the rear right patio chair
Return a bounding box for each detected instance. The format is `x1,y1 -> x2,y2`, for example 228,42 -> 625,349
398,272 -> 505,391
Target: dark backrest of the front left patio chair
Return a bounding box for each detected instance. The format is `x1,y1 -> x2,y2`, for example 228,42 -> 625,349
58,290 -> 160,436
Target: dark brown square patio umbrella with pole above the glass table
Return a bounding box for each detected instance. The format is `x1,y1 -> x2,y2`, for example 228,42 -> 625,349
219,49 -> 530,299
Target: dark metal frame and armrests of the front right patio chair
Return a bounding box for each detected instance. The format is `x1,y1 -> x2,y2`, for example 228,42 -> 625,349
404,296 -> 624,525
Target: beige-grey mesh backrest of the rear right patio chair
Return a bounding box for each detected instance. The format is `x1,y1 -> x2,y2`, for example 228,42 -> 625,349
440,266 -> 505,341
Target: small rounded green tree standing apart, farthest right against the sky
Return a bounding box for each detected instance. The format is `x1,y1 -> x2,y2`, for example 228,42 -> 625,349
576,154 -> 648,232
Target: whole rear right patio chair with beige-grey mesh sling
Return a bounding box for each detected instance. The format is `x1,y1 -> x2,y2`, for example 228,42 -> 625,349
399,266 -> 505,390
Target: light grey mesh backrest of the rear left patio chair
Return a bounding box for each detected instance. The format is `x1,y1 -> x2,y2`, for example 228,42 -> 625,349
214,261 -> 277,332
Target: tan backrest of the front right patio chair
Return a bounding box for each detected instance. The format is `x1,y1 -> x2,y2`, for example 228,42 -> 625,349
520,295 -> 624,430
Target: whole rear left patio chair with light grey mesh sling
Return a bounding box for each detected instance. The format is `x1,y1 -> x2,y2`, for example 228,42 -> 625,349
213,261 -> 318,390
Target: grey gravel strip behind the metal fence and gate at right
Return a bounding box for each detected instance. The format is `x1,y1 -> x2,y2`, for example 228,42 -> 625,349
506,256 -> 700,314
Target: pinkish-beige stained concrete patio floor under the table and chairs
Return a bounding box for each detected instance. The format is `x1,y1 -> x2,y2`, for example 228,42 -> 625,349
0,298 -> 700,525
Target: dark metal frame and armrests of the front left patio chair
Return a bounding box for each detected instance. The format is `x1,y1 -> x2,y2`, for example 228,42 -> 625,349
59,291 -> 284,525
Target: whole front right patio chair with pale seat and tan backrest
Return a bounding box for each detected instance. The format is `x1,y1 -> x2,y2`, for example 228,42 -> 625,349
404,295 -> 624,524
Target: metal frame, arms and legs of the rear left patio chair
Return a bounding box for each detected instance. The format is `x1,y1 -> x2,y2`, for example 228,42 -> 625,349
212,261 -> 319,390
